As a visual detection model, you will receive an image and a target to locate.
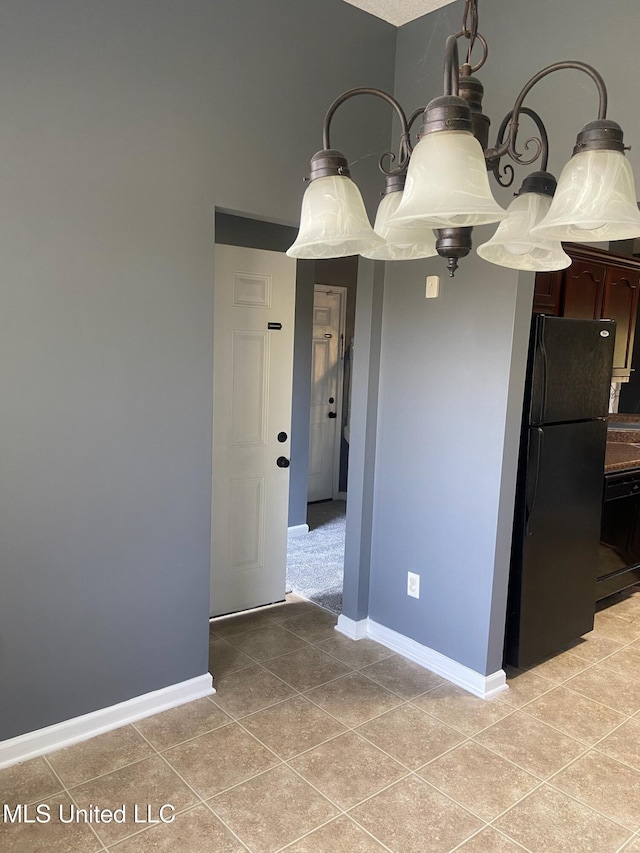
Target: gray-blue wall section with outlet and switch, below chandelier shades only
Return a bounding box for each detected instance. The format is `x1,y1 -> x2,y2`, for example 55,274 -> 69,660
369,250 -> 531,673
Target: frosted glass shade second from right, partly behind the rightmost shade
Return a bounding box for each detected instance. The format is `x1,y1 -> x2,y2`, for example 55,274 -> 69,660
478,192 -> 571,272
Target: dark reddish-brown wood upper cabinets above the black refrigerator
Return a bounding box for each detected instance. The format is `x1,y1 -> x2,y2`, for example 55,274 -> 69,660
533,243 -> 640,382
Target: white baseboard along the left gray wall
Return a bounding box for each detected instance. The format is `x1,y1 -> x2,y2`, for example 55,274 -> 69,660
0,672 -> 216,768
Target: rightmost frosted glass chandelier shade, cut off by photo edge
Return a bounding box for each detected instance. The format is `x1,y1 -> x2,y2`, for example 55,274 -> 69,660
533,149 -> 640,243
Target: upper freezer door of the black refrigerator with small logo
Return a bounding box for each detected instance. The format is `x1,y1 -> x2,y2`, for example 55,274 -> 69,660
529,314 -> 615,425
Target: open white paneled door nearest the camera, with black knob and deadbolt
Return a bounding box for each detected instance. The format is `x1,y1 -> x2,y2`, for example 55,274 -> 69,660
211,245 -> 296,616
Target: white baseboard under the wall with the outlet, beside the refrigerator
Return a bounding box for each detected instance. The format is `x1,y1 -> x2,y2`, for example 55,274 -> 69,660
336,615 -> 509,699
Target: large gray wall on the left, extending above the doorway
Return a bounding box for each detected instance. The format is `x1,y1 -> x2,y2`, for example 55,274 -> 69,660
0,0 -> 396,739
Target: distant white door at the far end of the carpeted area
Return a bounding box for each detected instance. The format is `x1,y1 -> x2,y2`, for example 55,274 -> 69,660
307,284 -> 346,501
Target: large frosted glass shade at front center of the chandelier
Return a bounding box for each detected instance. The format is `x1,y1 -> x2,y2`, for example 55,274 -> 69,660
390,130 -> 506,228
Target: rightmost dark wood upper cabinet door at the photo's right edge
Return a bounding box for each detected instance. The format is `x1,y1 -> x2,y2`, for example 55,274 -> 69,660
602,267 -> 640,379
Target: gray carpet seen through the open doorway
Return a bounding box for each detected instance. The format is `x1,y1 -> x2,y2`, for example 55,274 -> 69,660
287,501 -> 347,613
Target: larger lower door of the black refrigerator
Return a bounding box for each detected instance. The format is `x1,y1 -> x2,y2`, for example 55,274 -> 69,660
506,420 -> 606,666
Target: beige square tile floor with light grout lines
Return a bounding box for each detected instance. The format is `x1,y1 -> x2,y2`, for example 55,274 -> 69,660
0,589 -> 640,853
